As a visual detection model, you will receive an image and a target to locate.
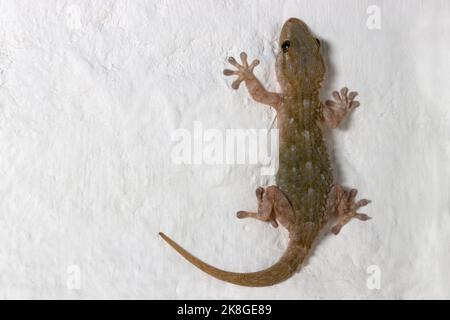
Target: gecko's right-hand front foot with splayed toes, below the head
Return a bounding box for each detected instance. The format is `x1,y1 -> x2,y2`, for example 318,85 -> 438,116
322,87 -> 359,128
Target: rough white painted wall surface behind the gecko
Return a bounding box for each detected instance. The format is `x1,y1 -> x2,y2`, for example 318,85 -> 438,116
0,0 -> 450,299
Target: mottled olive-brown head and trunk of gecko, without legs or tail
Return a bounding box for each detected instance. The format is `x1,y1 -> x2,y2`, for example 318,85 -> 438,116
276,19 -> 333,250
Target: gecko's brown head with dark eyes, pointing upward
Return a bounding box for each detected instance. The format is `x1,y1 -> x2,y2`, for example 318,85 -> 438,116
276,18 -> 325,91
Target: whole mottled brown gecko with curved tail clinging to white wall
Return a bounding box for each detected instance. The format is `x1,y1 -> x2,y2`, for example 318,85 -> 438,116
159,18 -> 370,287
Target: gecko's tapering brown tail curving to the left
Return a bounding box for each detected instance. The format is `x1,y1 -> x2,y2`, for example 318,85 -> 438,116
159,232 -> 308,287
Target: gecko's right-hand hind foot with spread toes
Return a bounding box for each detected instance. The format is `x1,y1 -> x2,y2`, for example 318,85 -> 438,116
331,185 -> 371,235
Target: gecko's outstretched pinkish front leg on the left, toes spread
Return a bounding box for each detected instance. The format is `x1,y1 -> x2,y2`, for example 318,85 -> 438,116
223,52 -> 281,109
